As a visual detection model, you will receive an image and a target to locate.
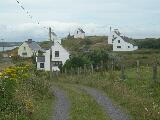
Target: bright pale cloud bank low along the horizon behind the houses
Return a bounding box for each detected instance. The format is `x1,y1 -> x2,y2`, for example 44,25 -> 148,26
0,21 -> 160,41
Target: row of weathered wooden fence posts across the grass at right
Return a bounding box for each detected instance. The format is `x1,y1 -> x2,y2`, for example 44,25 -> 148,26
56,60 -> 160,82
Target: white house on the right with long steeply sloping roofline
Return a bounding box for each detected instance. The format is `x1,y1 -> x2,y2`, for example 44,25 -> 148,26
108,29 -> 138,51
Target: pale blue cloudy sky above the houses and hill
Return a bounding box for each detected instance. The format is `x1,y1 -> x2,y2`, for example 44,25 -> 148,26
0,0 -> 160,41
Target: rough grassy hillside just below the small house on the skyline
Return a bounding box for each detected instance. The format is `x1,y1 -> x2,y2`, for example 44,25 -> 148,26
62,36 -> 112,52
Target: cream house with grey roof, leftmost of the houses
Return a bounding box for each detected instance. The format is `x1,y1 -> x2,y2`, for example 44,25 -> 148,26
18,39 -> 43,58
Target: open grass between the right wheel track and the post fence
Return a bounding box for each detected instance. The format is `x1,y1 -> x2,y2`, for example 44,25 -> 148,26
55,67 -> 160,120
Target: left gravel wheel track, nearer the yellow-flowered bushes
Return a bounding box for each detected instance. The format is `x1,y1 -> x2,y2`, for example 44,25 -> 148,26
53,88 -> 70,120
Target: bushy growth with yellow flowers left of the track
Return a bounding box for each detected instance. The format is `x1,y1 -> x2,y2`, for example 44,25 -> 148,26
0,66 -> 49,120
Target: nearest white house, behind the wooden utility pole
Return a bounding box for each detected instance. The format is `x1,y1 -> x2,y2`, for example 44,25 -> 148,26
36,41 -> 70,71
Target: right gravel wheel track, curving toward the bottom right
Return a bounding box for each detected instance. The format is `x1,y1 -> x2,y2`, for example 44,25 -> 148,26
81,86 -> 130,120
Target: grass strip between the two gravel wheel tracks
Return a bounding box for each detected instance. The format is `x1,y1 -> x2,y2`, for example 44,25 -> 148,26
54,84 -> 109,120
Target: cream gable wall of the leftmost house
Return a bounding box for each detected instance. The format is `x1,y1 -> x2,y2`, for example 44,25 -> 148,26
18,42 -> 33,57
